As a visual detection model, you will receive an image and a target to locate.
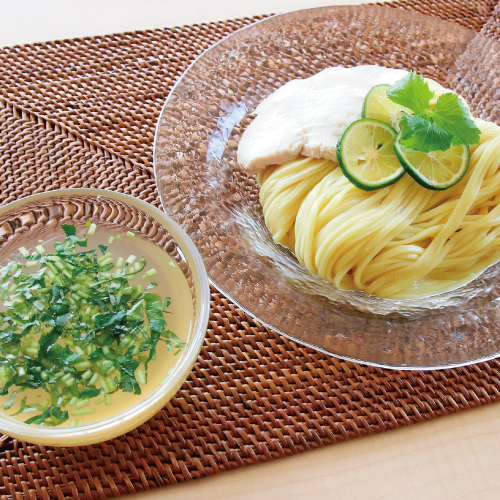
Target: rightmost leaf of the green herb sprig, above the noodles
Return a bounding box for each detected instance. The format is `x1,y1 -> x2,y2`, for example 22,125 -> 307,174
429,92 -> 481,146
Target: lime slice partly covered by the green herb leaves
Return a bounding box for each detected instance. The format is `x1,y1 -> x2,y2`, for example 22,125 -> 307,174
394,132 -> 470,190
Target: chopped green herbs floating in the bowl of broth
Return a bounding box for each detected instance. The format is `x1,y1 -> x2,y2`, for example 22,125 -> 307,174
0,226 -> 184,426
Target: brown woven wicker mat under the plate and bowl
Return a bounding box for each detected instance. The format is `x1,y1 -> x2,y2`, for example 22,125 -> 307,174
0,0 -> 500,499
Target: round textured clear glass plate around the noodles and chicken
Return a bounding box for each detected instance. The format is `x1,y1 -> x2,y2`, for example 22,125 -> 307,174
154,6 -> 500,369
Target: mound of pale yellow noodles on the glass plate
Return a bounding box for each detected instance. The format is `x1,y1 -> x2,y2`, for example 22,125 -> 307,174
257,120 -> 500,299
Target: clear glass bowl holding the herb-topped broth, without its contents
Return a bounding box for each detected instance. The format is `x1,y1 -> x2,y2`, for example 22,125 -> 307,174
0,189 -> 210,446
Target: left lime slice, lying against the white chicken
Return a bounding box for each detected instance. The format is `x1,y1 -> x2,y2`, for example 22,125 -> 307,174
337,118 -> 405,191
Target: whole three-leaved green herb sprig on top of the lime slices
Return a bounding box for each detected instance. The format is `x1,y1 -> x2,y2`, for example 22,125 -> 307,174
387,71 -> 480,153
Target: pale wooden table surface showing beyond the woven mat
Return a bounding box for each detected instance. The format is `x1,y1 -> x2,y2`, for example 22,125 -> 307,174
0,0 -> 500,500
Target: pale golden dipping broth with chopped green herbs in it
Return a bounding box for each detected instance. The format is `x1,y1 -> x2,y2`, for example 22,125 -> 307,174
0,224 -> 193,427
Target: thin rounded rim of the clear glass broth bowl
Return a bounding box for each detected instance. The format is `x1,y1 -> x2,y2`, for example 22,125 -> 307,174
0,188 -> 210,443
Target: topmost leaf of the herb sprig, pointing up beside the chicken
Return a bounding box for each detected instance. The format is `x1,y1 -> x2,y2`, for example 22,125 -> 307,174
387,71 -> 434,115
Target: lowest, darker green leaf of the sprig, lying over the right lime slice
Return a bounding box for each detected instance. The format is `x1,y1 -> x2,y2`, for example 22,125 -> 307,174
400,116 -> 453,153
